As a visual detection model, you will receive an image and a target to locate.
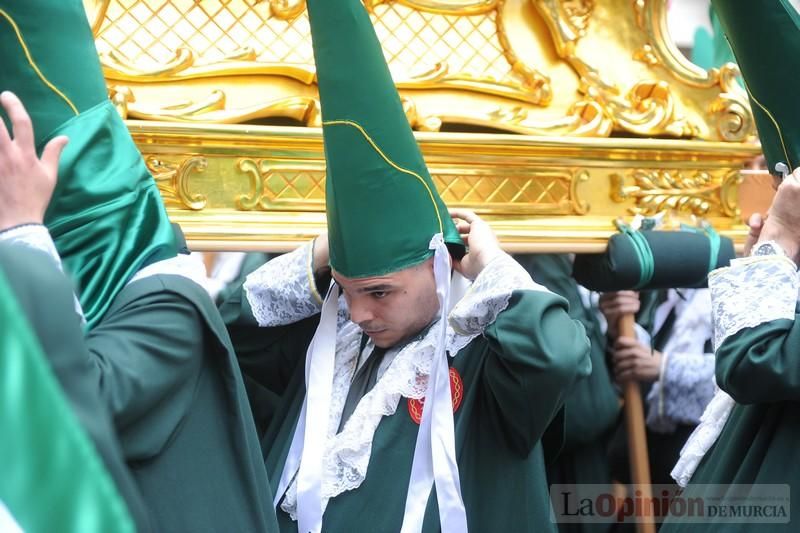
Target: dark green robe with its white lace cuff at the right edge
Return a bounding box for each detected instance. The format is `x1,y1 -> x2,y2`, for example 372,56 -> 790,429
661,256 -> 800,533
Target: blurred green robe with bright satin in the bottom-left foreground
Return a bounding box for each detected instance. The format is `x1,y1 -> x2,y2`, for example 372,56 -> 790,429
0,242 -> 137,533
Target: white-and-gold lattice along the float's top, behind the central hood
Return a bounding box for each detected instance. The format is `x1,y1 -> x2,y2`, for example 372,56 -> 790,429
97,0 -> 512,81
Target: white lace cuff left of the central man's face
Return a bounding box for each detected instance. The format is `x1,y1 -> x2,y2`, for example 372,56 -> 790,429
244,241 -> 322,327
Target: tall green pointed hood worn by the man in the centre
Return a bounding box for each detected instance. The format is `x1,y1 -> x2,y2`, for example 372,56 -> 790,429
308,0 -> 463,278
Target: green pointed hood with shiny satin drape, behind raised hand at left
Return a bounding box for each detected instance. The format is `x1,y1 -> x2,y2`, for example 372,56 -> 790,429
0,0 -> 177,327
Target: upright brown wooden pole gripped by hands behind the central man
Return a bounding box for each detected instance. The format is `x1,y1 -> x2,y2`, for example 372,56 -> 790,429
618,314 -> 656,533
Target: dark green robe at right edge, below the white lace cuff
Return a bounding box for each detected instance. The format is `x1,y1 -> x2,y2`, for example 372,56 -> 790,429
661,314 -> 800,533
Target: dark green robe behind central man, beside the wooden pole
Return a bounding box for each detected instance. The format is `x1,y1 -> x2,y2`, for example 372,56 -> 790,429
515,254 -> 620,532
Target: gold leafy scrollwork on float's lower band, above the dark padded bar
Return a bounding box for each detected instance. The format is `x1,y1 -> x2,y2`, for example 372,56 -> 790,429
609,170 -> 739,216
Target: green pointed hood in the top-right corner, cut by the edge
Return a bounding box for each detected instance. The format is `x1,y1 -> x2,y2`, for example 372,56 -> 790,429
712,0 -> 800,173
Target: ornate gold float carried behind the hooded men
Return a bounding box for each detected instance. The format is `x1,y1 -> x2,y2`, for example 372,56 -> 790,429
85,0 -> 759,251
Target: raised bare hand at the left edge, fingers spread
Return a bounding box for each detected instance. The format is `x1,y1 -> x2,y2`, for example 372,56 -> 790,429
0,91 -> 67,231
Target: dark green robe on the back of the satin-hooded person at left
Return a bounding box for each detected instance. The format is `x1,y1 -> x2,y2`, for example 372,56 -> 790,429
2,229 -> 277,533
